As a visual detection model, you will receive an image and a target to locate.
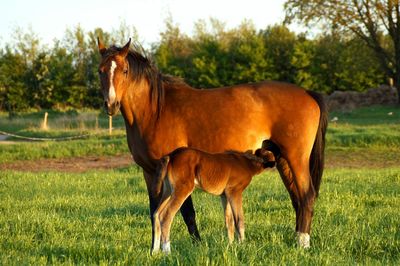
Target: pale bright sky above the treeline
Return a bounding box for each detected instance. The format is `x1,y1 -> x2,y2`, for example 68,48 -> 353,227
0,0 -> 294,46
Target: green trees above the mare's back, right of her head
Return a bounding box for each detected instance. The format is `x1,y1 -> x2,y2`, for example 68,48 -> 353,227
152,20 -> 386,93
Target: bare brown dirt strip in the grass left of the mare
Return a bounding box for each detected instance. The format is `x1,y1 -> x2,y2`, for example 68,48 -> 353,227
0,155 -> 133,173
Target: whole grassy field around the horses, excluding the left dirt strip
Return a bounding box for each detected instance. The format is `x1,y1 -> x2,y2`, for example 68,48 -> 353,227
0,107 -> 400,265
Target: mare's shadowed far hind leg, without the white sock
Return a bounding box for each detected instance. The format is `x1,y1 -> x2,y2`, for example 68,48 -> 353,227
276,157 -> 299,232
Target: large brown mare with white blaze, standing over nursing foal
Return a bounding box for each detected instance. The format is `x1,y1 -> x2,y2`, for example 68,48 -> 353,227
98,40 -> 327,247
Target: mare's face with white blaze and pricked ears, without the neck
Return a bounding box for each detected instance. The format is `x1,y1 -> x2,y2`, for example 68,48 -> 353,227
97,39 -> 131,115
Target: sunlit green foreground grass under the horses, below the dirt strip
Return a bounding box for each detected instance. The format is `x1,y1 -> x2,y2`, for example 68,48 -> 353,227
0,167 -> 400,265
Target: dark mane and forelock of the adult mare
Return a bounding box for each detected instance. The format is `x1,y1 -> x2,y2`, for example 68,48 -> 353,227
105,44 -> 190,117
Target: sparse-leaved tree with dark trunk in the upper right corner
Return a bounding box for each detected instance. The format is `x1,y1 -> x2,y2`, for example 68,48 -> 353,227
285,0 -> 400,103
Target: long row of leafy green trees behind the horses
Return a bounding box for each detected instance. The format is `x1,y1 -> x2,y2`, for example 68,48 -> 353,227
0,19 -> 387,112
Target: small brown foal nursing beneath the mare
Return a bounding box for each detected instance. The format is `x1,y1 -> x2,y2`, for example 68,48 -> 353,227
152,143 -> 275,253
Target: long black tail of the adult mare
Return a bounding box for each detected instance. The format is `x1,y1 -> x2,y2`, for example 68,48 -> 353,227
307,91 -> 328,196
